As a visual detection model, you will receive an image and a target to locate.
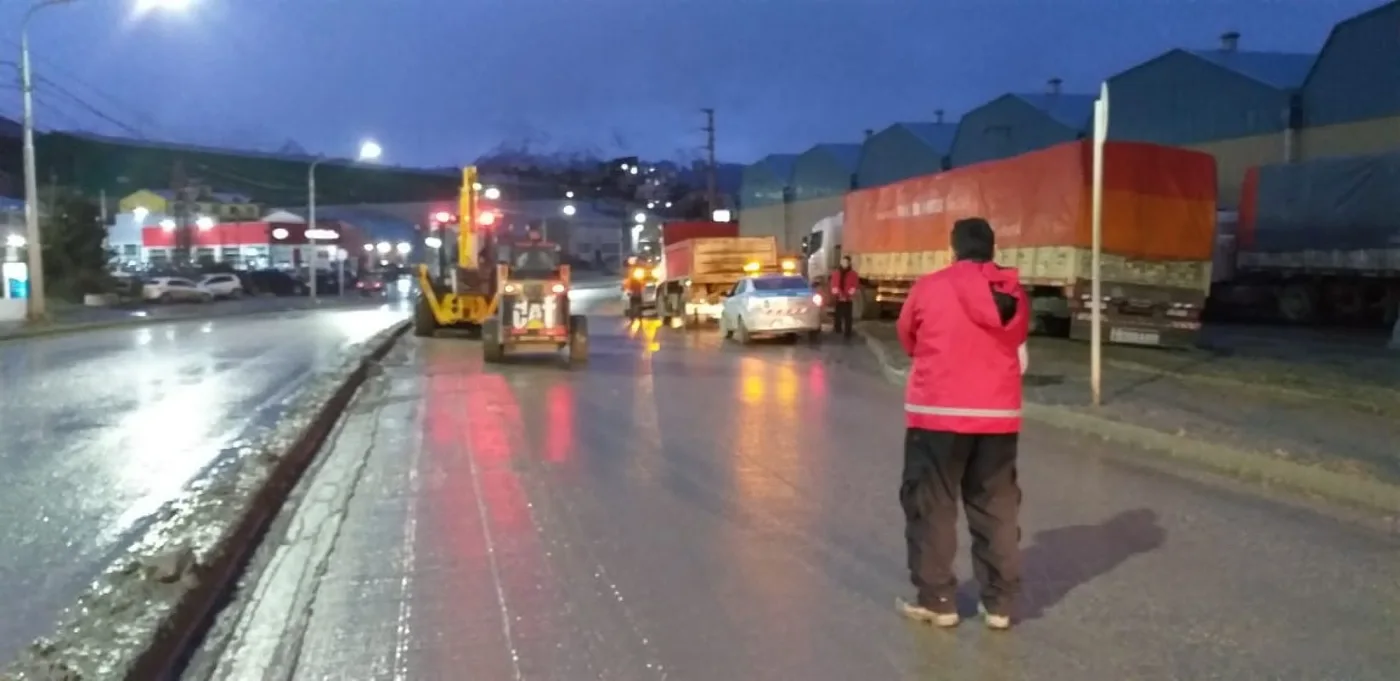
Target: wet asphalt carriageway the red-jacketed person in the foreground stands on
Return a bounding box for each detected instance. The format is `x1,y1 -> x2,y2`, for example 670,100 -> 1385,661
188,291 -> 1400,681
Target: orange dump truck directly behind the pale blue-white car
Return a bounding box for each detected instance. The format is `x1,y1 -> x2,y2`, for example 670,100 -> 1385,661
655,221 -> 780,325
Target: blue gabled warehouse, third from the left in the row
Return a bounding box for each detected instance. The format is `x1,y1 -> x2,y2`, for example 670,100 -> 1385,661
855,111 -> 958,188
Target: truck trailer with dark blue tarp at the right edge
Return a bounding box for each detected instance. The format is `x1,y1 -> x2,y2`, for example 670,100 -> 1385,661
1210,153 -> 1400,328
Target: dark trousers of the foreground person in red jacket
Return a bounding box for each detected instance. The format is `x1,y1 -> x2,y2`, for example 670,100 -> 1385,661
899,427 -> 1021,615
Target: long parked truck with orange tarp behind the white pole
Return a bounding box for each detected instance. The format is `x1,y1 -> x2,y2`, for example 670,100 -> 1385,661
806,142 -> 1215,345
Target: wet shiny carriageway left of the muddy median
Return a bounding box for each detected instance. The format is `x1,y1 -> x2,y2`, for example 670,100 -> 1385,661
0,304 -> 405,660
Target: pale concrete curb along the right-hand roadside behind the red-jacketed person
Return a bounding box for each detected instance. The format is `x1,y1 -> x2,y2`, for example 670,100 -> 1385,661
855,326 -> 1400,514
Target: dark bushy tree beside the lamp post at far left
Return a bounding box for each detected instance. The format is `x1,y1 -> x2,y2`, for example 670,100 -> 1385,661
42,189 -> 111,300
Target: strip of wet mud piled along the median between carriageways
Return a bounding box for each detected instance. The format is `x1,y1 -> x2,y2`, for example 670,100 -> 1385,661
0,322 -> 406,681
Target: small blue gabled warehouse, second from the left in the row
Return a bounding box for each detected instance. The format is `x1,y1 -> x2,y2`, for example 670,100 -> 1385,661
778,144 -> 861,254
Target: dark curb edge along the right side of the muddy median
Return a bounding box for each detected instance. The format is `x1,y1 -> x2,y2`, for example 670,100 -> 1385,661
3,321 -> 410,681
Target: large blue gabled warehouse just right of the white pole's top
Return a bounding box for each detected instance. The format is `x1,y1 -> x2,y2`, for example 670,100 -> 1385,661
1109,32 -> 1315,207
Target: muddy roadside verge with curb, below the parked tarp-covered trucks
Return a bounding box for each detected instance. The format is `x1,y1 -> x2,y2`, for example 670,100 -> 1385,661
860,324 -> 1400,510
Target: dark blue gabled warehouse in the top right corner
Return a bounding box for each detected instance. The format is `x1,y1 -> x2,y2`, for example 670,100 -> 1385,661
1299,1 -> 1400,158
